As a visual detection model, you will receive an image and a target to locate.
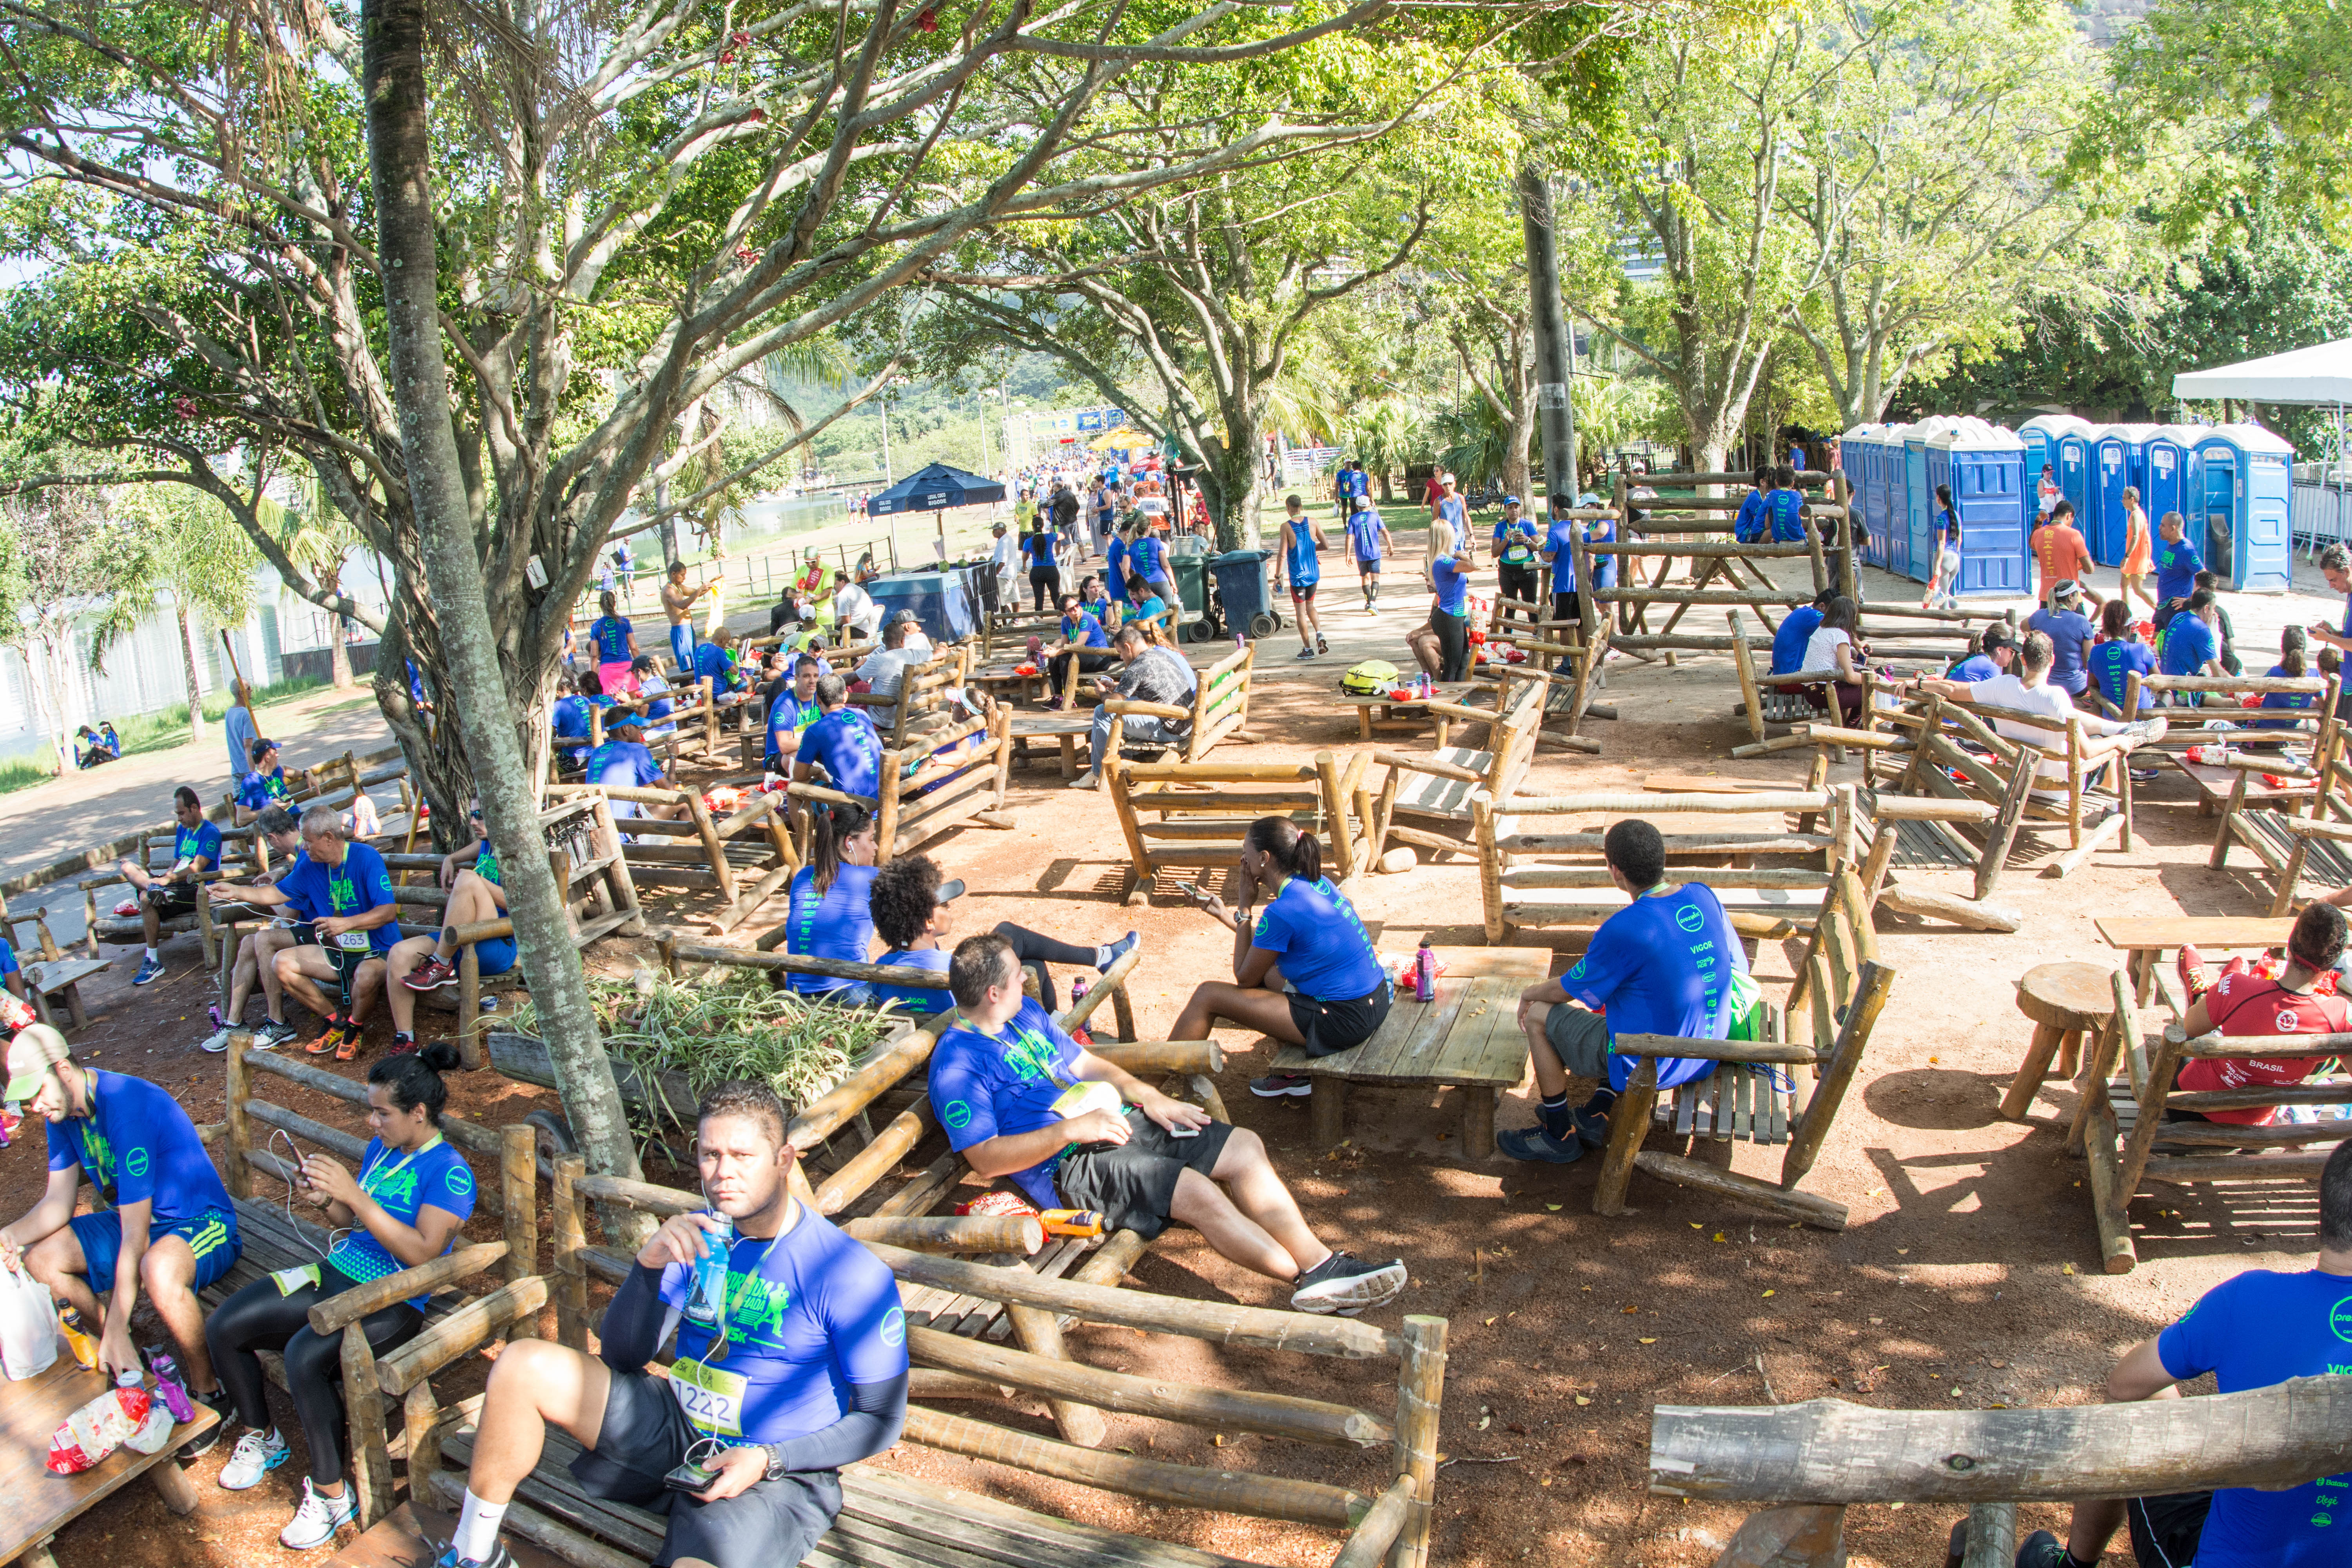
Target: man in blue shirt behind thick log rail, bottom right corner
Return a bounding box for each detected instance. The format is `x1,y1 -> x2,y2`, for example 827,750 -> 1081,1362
2018,1143 -> 2352,1568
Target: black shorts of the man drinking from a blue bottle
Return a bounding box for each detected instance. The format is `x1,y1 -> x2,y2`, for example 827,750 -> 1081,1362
572,1373 -> 842,1568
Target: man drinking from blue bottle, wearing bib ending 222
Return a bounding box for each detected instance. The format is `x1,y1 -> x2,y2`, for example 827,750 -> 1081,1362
437,1086 -> 908,1568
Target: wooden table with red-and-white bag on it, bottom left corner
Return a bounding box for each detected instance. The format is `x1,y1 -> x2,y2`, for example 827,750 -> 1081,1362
0,1345 -> 221,1568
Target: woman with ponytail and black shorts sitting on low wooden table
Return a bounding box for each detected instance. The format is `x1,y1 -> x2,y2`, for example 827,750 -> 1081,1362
1169,816 -> 1392,1100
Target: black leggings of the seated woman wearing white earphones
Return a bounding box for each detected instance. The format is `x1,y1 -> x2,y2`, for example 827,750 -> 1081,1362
205,1262 -> 426,1486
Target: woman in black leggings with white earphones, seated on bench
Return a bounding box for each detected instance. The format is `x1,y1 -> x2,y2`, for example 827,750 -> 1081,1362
205,1042 -> 475,1552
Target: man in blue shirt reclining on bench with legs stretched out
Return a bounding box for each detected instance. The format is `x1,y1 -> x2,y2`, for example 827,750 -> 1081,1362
929,933 -> 1404,1316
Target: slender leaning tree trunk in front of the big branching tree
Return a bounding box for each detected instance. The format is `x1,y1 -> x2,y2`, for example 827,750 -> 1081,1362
362,0 -> 640,1194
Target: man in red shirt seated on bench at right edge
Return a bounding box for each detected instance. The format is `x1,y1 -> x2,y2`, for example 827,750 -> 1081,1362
2164,903 -> 2352,1126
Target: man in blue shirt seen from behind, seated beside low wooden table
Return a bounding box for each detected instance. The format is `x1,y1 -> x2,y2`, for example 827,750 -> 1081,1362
1496,818 -> 1748,1166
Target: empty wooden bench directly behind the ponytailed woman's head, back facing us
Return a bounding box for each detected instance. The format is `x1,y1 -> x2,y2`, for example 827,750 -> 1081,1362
1103,752 -> 1376,903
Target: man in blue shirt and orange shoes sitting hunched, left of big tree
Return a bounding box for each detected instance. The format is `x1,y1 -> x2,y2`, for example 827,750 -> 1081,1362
245,806 -> 400,1063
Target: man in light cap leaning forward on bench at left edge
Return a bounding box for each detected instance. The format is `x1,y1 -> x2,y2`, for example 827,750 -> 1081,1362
0,1023 -> 242,1453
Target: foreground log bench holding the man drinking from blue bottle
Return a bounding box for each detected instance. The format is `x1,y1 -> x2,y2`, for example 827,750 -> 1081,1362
388,1157 -> 1446,1568
